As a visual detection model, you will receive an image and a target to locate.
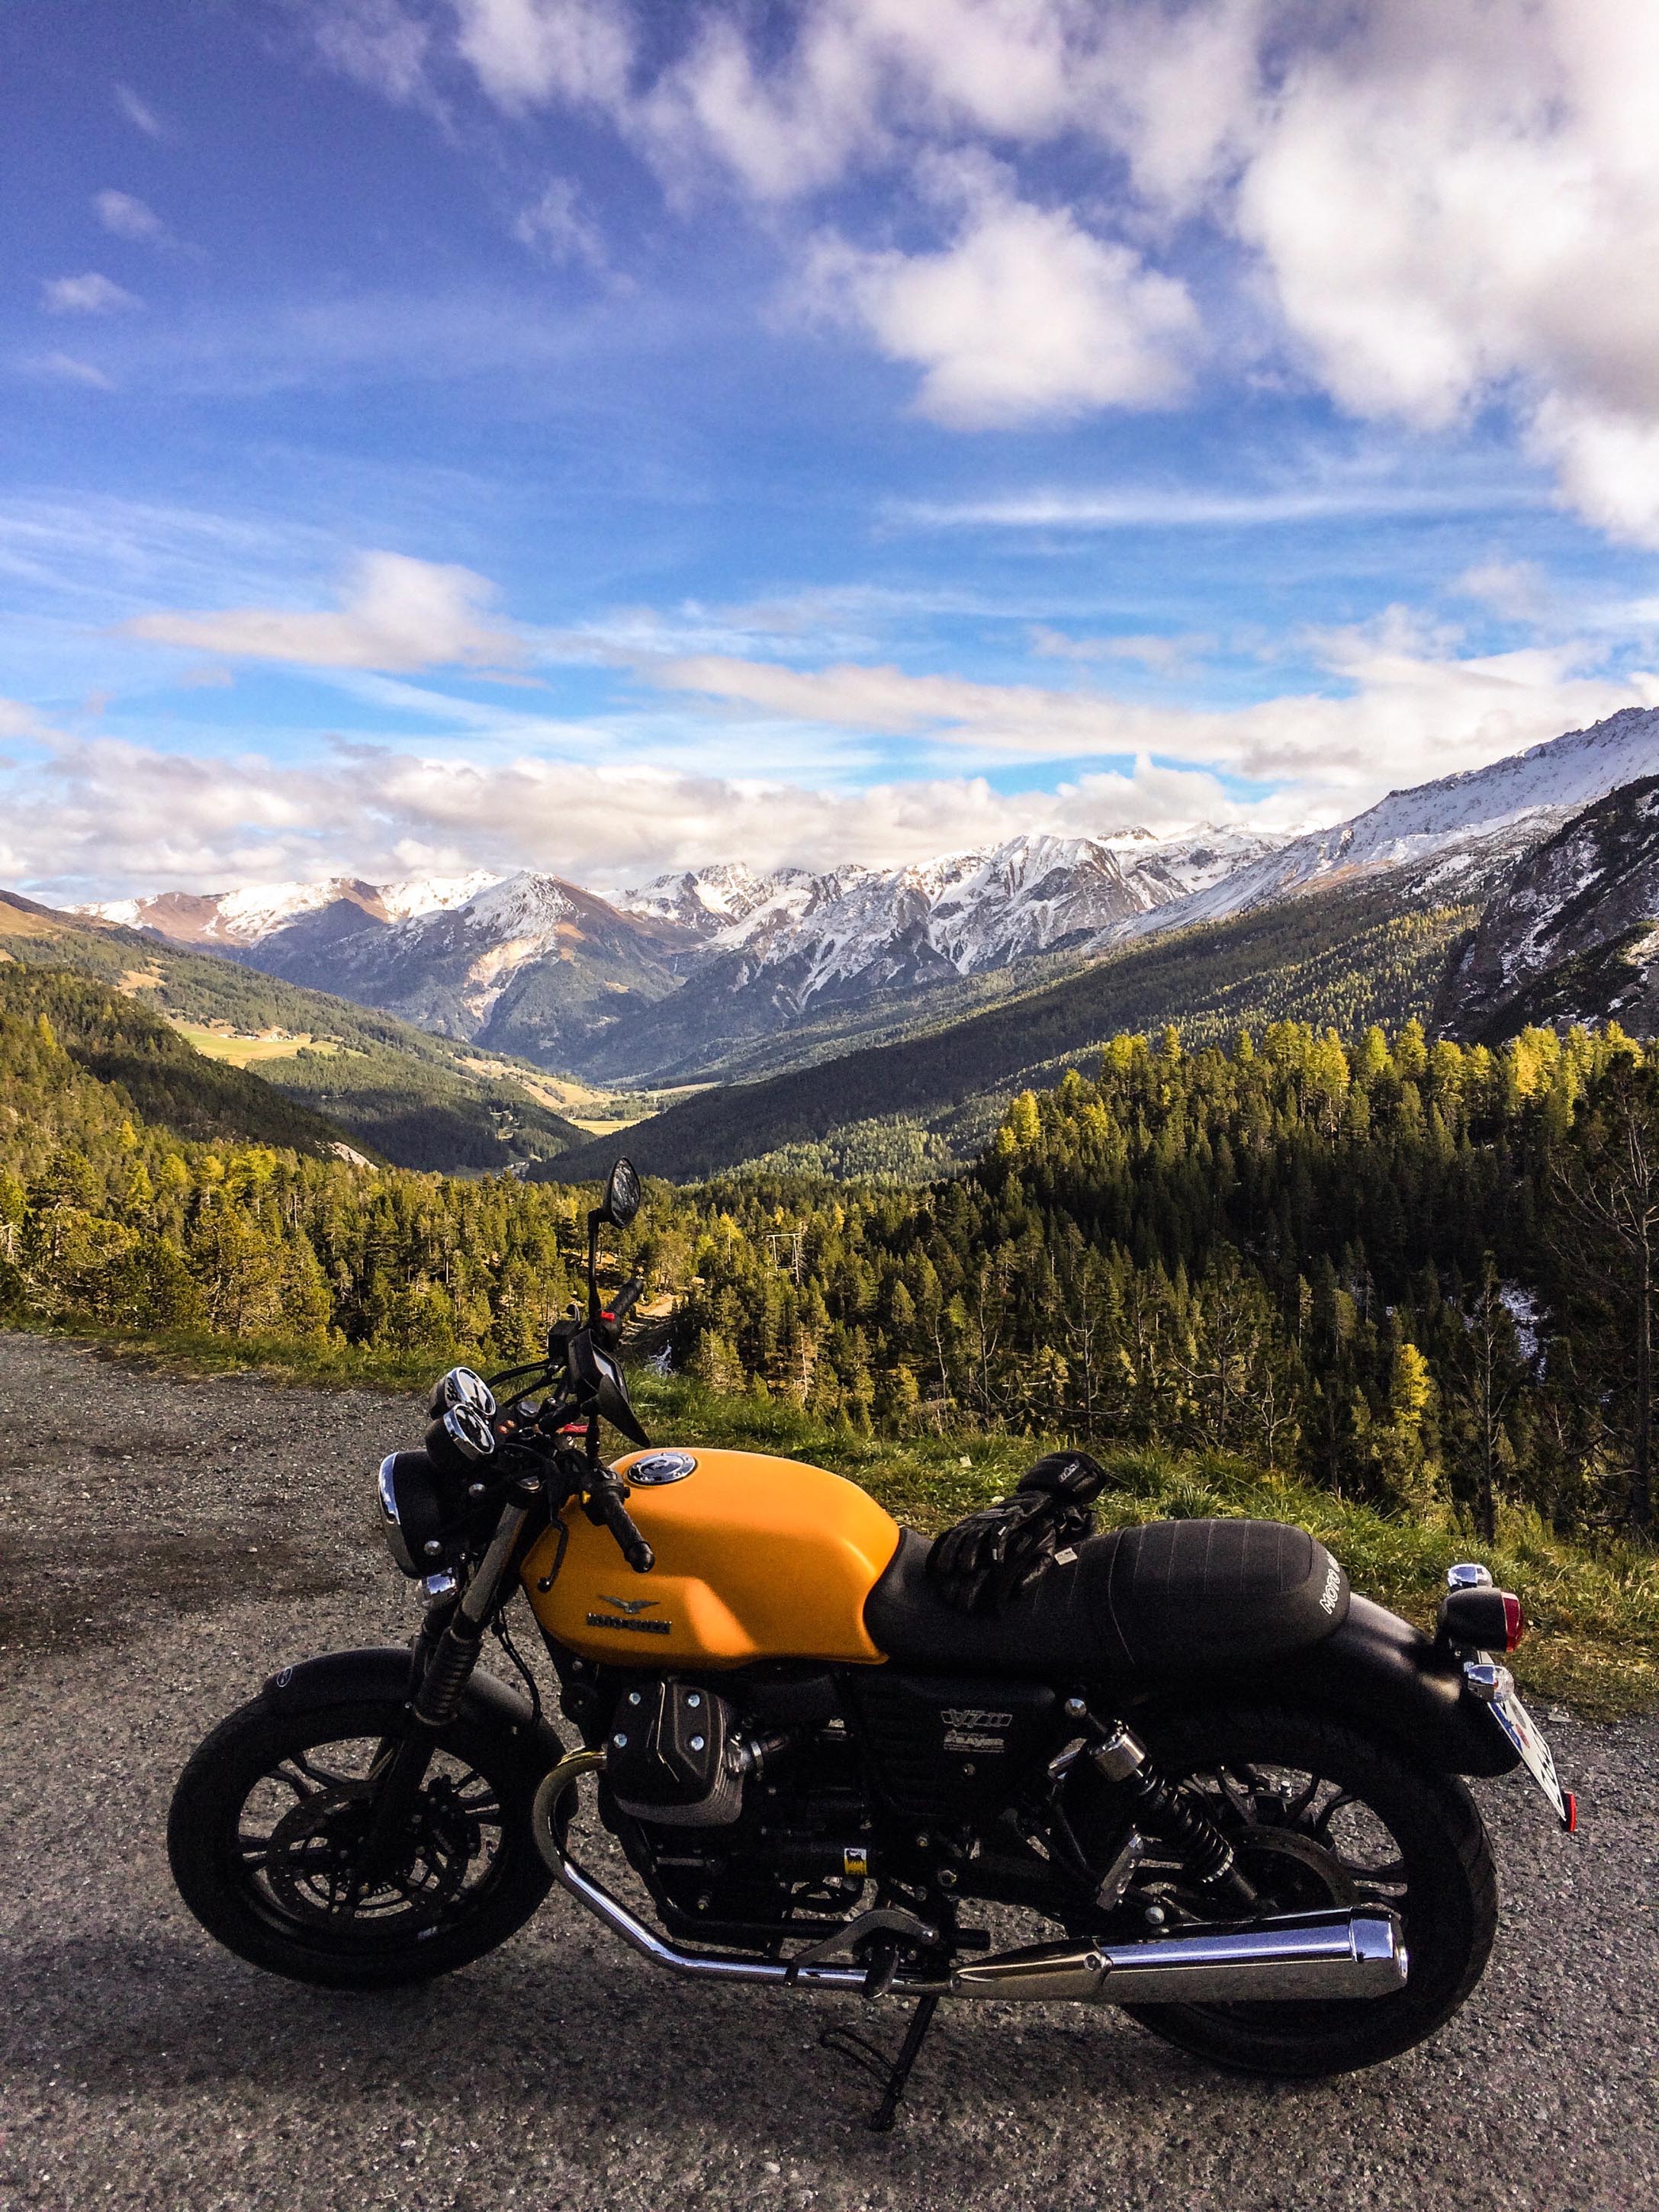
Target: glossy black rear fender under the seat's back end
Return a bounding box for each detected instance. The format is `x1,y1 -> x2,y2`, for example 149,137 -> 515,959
1155,1597 -> 1519,1774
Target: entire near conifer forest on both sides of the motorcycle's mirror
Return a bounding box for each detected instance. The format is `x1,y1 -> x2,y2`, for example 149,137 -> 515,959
0,966 -> 1659,1533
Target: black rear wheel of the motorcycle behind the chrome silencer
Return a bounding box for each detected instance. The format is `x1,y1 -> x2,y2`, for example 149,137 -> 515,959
1110,1708 -> 1497,2079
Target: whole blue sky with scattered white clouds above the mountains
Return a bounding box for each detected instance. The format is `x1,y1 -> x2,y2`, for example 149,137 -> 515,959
0,0 -> 1659,900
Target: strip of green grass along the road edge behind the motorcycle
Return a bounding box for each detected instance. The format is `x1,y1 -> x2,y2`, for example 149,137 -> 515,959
11,1323 -> 1659,1721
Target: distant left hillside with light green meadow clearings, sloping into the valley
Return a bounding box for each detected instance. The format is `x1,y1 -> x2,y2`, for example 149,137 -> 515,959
0,892 -> 584,1172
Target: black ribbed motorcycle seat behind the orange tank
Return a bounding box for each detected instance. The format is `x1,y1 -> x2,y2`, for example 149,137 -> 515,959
865,1519 -> 1347,1681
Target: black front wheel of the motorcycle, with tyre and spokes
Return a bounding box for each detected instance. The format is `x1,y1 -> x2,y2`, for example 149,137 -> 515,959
168,1696 -> 551,1989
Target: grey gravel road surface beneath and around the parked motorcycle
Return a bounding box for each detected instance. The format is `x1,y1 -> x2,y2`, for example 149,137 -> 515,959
0,1336 -> 1659,2212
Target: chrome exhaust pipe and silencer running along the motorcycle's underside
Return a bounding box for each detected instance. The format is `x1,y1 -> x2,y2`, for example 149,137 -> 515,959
531,1752 -> 1407,2004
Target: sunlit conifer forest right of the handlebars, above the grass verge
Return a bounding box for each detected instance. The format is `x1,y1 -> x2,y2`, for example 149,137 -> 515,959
679,1022 -> 1659,1526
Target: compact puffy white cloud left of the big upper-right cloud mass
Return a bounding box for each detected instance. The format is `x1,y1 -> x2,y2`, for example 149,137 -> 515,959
805,159 -> 1199,429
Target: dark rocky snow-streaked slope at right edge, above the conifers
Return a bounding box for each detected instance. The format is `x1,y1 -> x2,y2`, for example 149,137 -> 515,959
1436,776 -> 1659,1044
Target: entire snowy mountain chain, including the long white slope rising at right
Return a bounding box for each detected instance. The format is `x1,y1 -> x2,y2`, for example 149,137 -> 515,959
65,708 -> 1659,1084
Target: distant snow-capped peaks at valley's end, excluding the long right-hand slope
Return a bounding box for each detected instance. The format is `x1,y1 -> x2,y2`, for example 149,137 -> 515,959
74,830 -> 1272,1079
